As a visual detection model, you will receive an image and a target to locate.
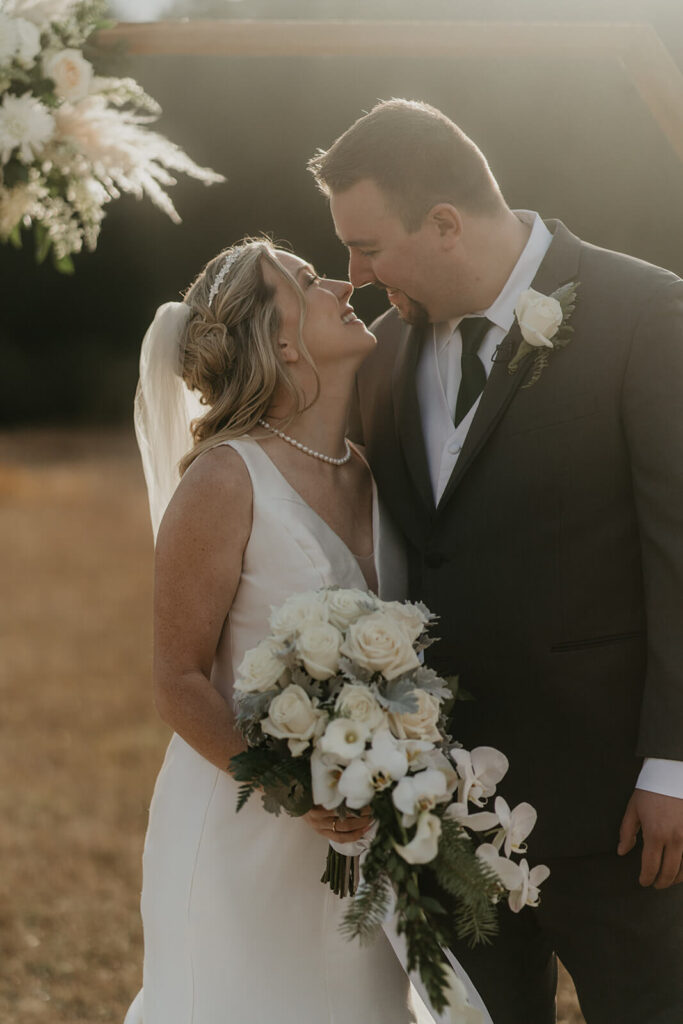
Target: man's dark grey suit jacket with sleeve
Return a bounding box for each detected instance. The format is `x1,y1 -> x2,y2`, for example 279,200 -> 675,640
353,222 -> 683,857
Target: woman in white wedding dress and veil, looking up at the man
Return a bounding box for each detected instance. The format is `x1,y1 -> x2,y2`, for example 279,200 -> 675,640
126,241 -> 415,1024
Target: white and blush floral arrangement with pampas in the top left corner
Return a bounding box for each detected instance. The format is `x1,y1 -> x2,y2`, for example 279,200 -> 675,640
0,0 -> 224,272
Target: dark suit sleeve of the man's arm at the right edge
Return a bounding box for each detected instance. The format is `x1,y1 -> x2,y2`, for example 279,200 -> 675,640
622,278 -> 683,760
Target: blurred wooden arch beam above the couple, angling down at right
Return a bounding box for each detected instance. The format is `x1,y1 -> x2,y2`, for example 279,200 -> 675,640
97,19 -> 683,163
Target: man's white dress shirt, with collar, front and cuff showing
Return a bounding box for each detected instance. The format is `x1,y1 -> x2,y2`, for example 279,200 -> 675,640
417,210 -> 683,799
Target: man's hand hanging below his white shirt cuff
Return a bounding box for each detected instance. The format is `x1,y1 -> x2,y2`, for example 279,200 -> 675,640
616,790 -> 683,889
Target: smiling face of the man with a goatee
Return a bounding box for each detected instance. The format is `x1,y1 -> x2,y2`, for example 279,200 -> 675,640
330,178 -> 440,324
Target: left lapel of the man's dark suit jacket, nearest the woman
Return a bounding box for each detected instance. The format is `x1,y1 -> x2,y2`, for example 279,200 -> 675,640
392,326 -> 434,511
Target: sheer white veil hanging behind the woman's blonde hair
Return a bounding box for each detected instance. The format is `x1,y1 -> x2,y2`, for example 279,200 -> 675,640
134,302 -> 206,540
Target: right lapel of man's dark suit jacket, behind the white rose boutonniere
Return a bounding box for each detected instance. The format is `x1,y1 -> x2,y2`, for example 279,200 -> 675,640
438,221 -> 581,510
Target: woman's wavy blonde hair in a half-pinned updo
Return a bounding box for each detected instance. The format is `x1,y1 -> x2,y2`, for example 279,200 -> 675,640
179,239 -> 315,475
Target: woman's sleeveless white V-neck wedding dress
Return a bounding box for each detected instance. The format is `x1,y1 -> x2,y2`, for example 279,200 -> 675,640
126,437 -> 424,1024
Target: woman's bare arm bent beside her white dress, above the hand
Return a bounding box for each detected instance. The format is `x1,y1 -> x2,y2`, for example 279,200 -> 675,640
154,446 -> 252,769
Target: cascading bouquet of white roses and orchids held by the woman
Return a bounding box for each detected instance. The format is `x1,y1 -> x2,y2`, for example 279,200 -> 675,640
230,588 -> 549,1013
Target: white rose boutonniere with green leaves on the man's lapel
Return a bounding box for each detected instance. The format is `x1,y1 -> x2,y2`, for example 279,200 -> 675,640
508,281 -> 579,387
